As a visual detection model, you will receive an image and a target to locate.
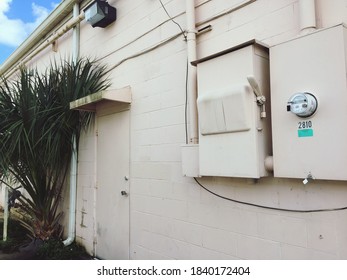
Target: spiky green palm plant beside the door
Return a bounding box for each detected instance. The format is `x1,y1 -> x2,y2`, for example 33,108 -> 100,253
0,60 -> 109,240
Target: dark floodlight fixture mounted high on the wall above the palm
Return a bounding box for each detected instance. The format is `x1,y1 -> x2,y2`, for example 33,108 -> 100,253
83,0 -> 117,28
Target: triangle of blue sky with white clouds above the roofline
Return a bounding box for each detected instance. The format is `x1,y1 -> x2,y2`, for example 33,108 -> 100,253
0,0 -> 61,64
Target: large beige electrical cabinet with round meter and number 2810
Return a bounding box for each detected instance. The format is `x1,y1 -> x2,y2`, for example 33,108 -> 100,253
270,25 -> 347,183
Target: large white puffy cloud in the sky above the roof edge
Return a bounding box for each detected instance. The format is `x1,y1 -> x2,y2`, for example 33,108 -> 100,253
0,0 -> 50,47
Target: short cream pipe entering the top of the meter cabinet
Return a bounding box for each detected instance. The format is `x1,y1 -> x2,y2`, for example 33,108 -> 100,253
299,0 -> 317,35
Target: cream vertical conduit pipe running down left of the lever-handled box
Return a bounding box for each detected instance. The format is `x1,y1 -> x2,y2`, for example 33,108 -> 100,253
186,0 -> 199,144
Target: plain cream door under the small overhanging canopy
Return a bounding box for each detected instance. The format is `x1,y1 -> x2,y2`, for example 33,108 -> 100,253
96,106 -> 130,260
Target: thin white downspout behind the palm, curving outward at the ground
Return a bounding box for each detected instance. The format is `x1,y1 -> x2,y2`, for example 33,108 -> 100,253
63,3 -> 80,246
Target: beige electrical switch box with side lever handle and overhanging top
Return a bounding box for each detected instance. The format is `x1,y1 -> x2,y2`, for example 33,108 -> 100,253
193,40 -> 272,178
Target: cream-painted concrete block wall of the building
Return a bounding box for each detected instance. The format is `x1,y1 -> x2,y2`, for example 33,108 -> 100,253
2,0 -> 347,259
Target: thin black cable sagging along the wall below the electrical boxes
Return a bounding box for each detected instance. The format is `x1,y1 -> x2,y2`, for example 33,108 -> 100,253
194,177 -> 347,213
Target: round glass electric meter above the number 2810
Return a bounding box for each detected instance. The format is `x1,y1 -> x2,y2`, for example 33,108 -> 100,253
287,92 -> 318,118
